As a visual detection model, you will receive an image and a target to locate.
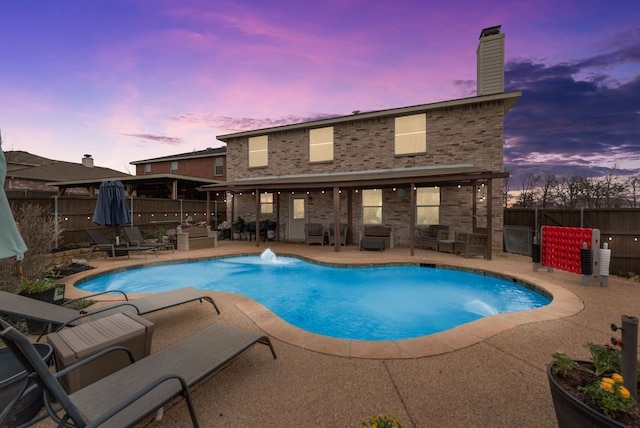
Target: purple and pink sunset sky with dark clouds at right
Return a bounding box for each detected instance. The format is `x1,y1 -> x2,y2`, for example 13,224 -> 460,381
0,0 -> 640,180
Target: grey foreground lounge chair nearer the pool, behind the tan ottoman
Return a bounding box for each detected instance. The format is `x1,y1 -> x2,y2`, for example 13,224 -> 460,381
0,287 -> 220,339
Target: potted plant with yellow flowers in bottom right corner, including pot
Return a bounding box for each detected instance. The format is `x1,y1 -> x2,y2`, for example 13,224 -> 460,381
547,324 -> 640,428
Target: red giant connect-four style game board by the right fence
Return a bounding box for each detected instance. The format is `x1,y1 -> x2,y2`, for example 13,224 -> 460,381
540,226 -> 593,274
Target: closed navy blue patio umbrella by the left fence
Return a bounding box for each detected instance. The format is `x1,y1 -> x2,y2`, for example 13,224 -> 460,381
93,181 -> 131,243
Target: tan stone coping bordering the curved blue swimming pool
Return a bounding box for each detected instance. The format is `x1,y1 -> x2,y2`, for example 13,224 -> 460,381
72,252 -> 584,359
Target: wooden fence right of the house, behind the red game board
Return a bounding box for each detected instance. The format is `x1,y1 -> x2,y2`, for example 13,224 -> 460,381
504,208 -> 640,275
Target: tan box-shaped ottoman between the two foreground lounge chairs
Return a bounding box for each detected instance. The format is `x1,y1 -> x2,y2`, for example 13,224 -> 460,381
47,313 -> 154,393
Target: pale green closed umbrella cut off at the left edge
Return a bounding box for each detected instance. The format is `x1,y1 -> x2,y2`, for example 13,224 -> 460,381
0,136 -> 27,262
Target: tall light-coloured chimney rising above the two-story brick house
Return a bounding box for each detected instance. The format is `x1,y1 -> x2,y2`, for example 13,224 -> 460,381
476,25 -> 504,96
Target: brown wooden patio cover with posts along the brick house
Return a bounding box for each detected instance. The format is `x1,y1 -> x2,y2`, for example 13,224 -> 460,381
199,164 -> 509,259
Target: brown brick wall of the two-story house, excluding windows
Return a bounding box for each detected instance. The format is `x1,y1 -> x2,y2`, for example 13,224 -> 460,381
227,101 -> 504,250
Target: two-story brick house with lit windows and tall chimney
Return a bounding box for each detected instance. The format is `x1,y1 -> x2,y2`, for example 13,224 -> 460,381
203,27 -> 522,257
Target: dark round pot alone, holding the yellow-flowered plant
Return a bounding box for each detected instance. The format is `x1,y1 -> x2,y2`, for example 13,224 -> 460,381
547,361 -> 625,428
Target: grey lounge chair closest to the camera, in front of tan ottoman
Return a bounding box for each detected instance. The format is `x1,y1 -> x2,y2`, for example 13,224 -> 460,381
0,320 -> 276,428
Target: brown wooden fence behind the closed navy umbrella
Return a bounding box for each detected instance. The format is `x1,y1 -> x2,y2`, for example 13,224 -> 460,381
9,196 -> 226,247
